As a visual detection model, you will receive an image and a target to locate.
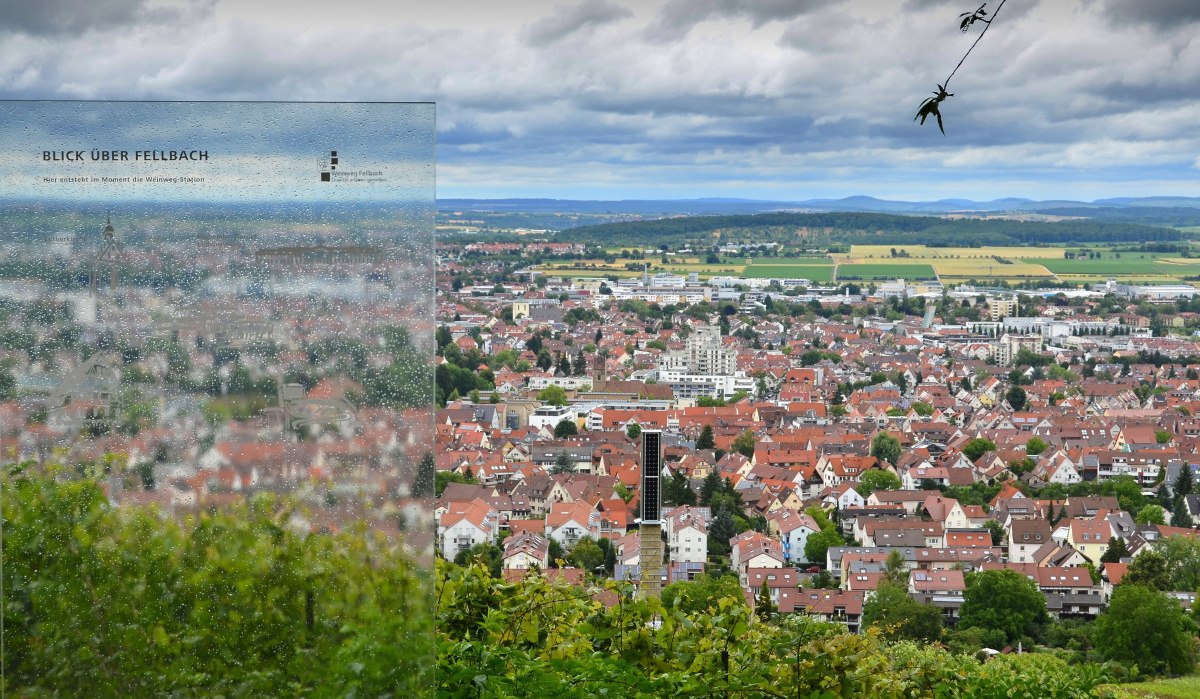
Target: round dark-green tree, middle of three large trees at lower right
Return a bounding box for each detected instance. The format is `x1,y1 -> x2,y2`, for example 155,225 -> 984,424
959,569 -> 1049,644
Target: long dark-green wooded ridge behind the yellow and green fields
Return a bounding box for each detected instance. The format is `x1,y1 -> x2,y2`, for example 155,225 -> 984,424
556,211 -> 1187,247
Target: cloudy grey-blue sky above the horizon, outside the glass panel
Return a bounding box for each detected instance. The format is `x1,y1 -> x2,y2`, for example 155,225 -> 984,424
0,0 -> 1200,199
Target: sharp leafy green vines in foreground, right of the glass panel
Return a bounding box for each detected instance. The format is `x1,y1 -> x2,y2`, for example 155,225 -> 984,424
437,562 -> 1120,699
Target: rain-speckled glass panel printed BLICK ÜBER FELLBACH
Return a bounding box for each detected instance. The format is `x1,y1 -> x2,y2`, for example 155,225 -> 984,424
0,102 -> 434,697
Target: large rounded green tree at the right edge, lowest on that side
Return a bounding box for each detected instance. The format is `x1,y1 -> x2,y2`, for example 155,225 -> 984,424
1094,586 -> 1196,675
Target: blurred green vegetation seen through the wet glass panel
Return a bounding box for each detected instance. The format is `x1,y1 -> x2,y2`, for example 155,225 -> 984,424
0,472 -> 433,698
